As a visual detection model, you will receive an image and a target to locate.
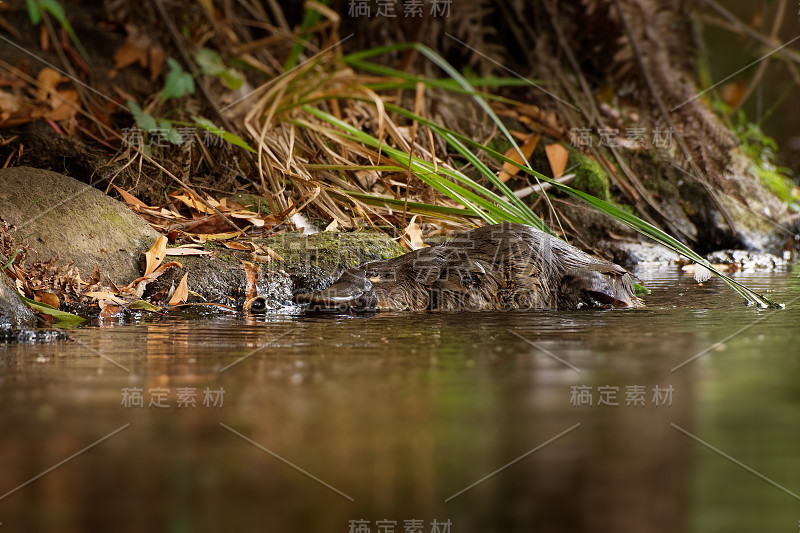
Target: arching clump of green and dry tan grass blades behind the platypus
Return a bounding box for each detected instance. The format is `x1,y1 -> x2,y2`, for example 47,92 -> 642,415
228,6 -> 776,306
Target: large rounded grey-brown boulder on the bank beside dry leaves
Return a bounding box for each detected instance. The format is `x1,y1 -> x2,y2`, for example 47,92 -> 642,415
0,167 -> 158,283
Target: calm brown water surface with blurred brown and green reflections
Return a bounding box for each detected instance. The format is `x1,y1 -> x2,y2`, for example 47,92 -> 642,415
0,271 -> 800,533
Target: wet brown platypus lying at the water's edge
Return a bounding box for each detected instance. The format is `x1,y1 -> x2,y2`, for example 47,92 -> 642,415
294,223 -> 643,311
